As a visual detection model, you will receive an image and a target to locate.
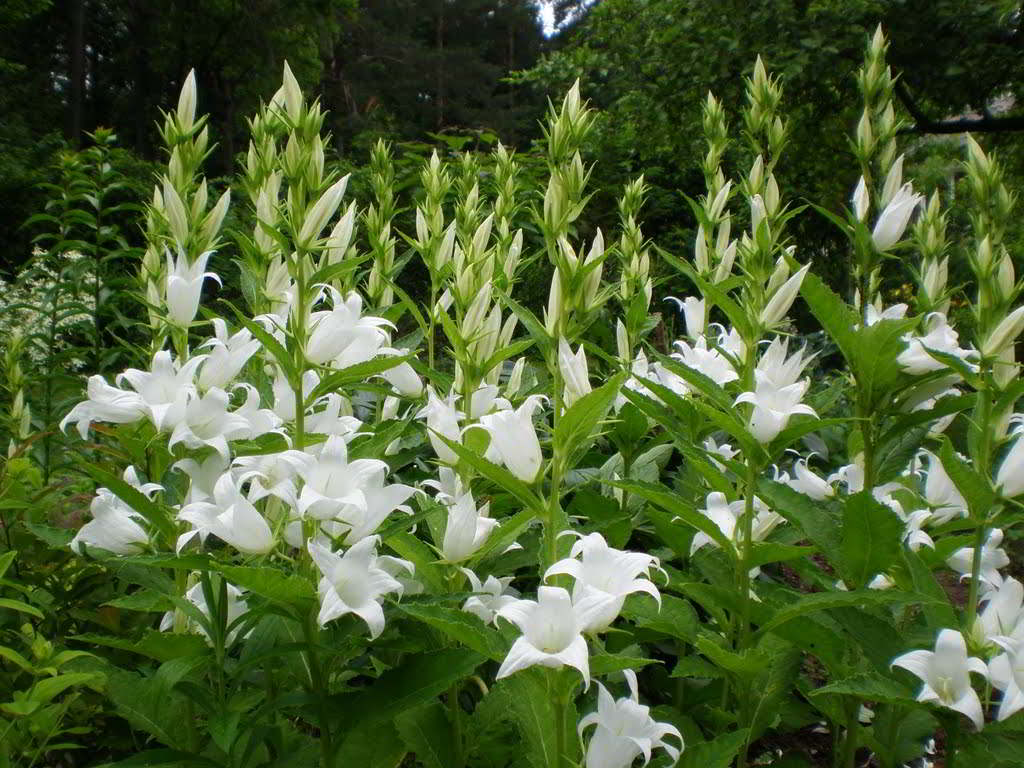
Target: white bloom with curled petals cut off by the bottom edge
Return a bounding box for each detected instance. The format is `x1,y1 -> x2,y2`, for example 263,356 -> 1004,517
577,670 -> 683,768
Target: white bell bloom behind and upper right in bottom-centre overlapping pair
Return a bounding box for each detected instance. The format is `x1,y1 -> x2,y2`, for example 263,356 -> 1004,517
544,532 -> 662,632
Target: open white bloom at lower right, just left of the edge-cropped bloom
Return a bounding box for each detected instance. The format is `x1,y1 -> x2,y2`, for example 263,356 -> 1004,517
892,630 -> 988,730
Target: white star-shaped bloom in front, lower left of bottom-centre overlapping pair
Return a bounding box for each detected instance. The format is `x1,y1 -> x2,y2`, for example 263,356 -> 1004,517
497,587 -> 600,687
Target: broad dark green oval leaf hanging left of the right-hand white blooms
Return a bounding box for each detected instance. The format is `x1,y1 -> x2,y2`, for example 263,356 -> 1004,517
841,490 -> 903,589
